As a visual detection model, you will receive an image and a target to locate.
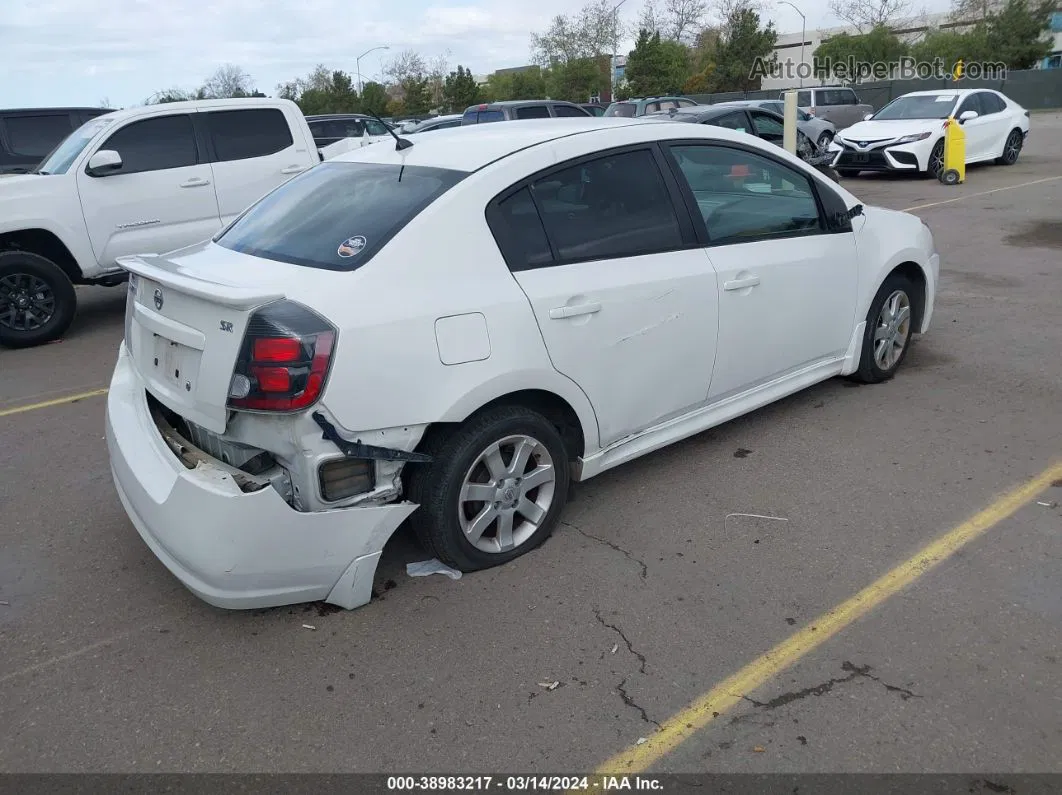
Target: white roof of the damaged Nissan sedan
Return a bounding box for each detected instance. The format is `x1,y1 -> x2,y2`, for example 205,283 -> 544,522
326,117 -> 798,172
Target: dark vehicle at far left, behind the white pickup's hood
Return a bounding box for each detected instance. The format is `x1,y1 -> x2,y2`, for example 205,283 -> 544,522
0,107 -> 109,174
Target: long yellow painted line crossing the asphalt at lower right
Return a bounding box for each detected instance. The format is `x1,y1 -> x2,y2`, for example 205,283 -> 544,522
597,463 -> 1062,776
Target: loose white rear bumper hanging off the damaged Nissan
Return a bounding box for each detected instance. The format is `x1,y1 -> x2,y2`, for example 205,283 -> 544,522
106,343 -> 416,609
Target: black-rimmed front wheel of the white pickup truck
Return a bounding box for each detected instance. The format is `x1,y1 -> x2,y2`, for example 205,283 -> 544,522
0,250 -> 78,348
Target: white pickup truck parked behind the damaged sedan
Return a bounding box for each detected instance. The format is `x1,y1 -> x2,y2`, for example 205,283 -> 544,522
0,98 -> 323,347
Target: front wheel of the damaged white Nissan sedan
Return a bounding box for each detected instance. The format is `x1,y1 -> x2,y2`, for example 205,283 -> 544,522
851,274 -> 918,383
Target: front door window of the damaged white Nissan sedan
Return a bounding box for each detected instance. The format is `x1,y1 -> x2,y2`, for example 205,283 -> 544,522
670,145 -> 823,244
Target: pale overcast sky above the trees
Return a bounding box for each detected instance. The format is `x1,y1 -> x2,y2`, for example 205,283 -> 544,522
0,0 -> 947,107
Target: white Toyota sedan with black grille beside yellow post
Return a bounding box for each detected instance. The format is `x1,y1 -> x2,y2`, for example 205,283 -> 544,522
830,88 -> 1030,177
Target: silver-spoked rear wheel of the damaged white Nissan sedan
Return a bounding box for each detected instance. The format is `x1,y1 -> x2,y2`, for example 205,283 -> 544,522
409,405 -> 571,572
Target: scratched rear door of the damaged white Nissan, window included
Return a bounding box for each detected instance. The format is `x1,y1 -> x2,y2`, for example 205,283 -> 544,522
490,148 -> 718,445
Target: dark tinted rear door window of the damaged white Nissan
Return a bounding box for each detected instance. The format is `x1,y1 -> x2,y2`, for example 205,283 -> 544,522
532,150 -> 682,261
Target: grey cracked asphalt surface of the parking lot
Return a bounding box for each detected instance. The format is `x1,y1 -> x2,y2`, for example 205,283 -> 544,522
0,115 -> 1062,774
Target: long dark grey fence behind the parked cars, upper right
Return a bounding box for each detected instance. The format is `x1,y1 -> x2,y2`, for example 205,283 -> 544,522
689,69 -> 1062,110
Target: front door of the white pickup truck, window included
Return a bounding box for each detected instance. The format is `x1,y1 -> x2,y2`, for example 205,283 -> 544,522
76,114 -> 221,269
